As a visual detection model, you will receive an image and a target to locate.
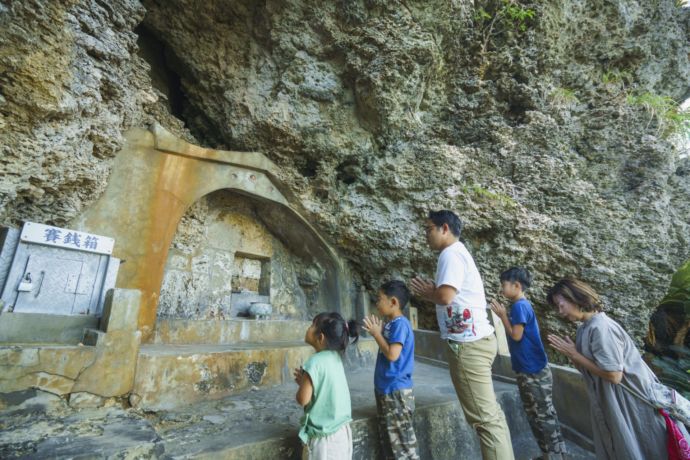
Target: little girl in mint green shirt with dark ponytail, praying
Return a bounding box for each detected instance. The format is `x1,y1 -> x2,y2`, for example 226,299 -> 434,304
294,313 -> 359,460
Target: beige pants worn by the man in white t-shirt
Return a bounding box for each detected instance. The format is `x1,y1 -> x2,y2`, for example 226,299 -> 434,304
447,334 -> 515,460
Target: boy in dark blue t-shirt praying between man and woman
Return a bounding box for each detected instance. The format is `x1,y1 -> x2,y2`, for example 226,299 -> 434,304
491,267 -> 566,459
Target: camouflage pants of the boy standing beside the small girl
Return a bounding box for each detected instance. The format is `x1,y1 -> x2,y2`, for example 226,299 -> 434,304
376,388 -> 419,460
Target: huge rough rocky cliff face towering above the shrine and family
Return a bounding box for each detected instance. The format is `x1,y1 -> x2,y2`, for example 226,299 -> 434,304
0,0 -> 690,344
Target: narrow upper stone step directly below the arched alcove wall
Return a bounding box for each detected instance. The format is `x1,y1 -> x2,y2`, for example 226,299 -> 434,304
153,319 -> 311,345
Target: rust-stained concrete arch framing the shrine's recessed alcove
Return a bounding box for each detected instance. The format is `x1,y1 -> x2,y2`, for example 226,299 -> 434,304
73,125 -> 354,341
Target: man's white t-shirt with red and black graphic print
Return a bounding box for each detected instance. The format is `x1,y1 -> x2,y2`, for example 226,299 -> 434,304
436,241 -> 494,342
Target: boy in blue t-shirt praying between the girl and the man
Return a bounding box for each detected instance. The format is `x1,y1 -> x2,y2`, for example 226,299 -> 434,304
364,281 -> 419,459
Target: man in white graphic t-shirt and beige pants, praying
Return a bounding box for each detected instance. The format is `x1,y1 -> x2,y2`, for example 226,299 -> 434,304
410,211 -> 514,460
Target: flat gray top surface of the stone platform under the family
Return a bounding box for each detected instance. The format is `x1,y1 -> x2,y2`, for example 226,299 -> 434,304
0,363 -> 594,460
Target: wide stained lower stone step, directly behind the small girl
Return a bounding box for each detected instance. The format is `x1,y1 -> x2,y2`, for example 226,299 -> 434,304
130,339 -> 378,410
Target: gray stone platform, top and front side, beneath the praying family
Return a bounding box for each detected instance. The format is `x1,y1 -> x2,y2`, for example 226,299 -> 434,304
0,362 -> 594,460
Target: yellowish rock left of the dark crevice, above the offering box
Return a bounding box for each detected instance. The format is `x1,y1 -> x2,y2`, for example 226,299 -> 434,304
0,0 -> 191,224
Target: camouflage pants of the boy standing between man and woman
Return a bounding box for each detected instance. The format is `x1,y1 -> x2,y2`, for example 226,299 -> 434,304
517,365 -> 565,458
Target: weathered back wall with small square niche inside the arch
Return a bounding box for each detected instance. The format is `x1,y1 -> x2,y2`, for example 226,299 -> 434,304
158,191 -> 322,319
